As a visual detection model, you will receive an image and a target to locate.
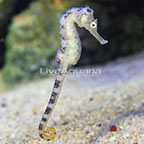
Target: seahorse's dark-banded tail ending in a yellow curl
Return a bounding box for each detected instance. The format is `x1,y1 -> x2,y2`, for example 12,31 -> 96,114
39,68 -> 65,141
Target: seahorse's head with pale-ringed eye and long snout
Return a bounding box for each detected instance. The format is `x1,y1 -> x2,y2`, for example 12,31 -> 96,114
76,6 -> 108,44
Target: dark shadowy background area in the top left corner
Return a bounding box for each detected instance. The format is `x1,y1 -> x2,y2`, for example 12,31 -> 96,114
0,0 -> 34,68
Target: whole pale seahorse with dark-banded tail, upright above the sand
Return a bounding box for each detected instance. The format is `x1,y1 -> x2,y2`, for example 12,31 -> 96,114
39,6 -> 108,141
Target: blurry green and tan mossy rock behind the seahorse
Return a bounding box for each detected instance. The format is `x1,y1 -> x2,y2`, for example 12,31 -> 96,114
2,1 -> 67,86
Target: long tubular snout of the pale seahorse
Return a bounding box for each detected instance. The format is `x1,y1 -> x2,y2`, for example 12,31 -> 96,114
89,29 -> 108,45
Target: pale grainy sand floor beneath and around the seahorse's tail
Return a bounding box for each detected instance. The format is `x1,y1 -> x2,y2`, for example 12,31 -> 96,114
0,53 -> 144,144
